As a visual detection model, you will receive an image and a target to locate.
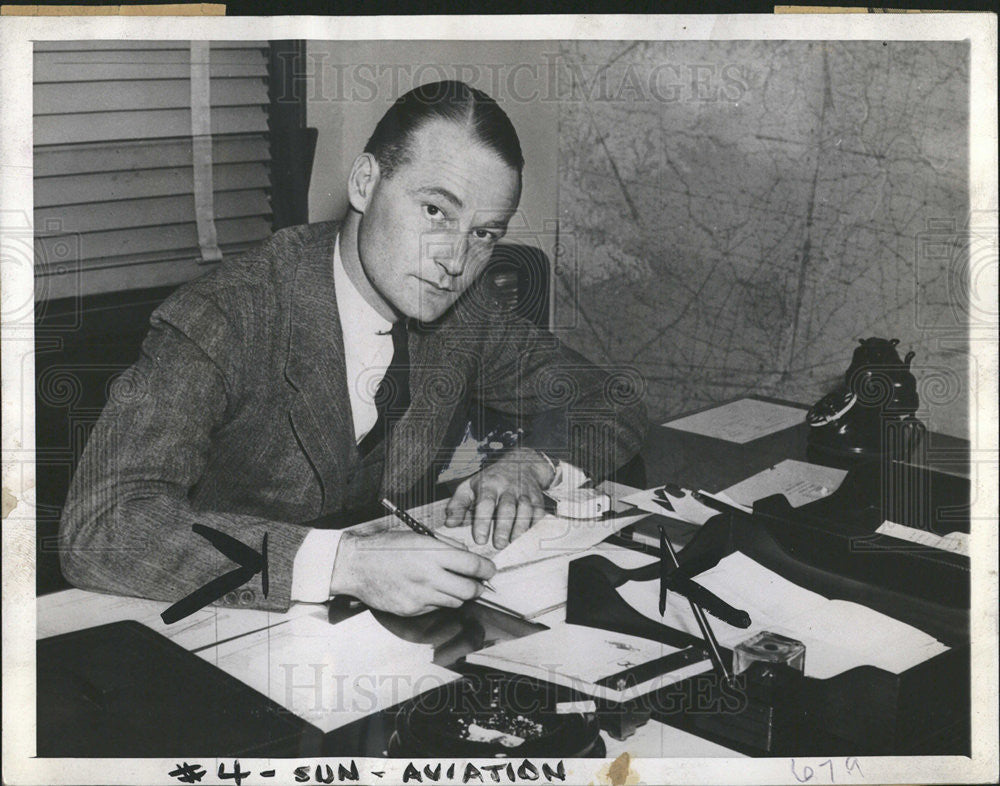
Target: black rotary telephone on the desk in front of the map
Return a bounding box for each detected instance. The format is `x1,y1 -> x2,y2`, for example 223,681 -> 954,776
806,337 -> 924,463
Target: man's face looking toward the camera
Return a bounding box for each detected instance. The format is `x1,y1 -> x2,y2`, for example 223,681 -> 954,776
358,120 -> 521,322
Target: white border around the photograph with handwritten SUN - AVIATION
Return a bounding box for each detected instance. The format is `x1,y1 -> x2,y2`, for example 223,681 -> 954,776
0,13 -> 998,784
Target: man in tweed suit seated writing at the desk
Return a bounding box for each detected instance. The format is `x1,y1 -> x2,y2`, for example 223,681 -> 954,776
61,82 -> 645,614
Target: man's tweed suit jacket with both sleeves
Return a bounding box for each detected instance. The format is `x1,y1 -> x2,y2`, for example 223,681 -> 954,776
60,223 -> 646,610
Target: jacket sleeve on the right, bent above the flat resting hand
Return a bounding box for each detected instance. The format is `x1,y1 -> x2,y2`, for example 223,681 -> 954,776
454,282 -> 648,482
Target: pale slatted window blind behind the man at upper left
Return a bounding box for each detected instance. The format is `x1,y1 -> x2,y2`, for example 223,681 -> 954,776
34,41 -> 271,276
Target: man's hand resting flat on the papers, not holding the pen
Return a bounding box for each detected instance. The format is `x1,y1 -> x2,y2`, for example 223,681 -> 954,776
445,448 -> 555,549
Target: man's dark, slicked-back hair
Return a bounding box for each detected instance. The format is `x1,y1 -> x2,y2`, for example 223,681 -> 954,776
364,81 -> 524,178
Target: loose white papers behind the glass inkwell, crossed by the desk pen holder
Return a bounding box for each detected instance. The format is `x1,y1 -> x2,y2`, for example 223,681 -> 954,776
618,552 -> 948,679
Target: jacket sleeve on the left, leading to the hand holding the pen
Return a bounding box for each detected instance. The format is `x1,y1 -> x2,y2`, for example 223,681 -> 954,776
60,290 -> 309,610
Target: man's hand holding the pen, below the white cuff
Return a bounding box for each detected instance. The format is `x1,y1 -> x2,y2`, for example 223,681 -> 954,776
330,531 -> 496,616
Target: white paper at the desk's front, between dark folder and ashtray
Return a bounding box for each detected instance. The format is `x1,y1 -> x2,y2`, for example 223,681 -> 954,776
199,611 -> 459,732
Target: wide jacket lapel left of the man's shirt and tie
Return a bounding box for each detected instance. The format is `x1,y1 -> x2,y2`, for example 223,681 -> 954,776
285,223 -> 357,513
